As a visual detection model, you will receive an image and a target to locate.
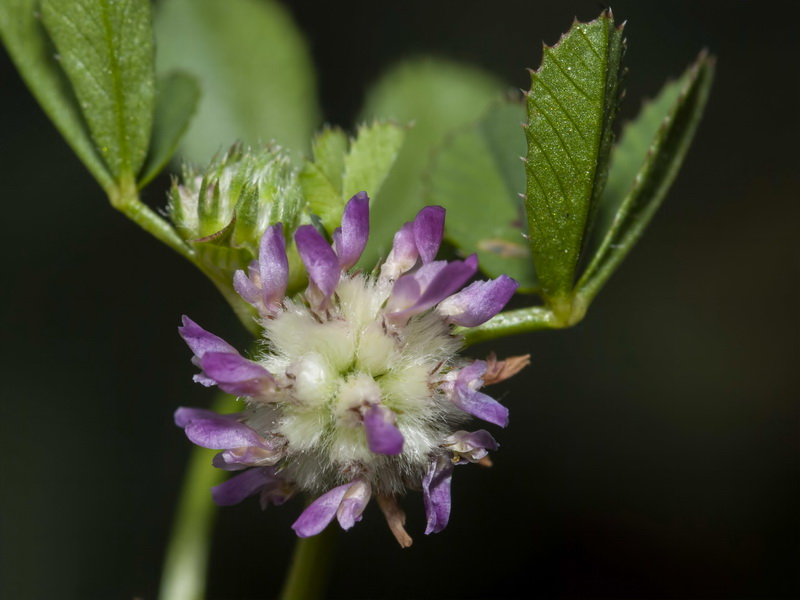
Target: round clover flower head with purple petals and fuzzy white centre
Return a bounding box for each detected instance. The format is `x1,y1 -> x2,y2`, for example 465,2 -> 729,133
175,192 -> 527,546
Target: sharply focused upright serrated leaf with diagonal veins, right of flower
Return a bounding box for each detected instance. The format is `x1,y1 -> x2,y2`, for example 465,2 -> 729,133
525,11 -> 623,302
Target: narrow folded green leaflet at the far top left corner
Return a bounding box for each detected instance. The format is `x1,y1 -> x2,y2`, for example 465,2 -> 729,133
0,0 -> 113,190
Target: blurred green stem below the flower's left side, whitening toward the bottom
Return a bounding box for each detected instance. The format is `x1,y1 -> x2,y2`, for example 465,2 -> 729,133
158,394 -> 238,600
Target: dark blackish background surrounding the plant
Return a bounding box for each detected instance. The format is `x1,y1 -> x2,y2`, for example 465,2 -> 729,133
0,0 -> 800,600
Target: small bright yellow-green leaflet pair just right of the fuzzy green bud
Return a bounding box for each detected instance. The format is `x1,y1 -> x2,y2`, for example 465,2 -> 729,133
300,121 -> 406,233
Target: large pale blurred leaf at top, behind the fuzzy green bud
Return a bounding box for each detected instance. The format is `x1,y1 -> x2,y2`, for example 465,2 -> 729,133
156,0 -> 320,163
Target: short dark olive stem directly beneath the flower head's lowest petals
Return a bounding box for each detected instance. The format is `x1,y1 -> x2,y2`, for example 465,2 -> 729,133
280,526 -> 336,600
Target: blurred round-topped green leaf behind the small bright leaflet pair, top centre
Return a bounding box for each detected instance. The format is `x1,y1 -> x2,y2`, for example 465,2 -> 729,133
360,59 -> 503,269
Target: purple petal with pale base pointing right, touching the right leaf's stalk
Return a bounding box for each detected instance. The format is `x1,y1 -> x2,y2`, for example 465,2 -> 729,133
439,275 -> 519,327
